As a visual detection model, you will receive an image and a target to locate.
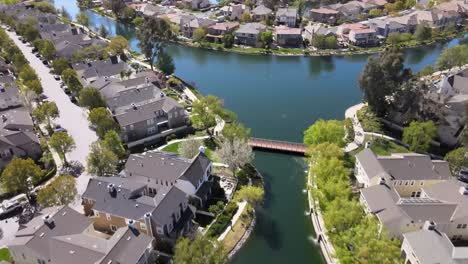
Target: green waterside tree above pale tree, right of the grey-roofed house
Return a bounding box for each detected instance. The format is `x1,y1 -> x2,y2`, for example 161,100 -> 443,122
190,95 -> 222,133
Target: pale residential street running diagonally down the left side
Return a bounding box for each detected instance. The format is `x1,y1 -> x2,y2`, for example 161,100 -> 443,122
7,31 -> 97,194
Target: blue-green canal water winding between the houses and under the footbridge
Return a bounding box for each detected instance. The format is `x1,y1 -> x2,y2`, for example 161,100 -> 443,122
55,0 -> 464,264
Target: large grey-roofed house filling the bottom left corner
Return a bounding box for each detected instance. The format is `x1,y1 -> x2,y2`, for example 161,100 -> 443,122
8,206 -> 154,264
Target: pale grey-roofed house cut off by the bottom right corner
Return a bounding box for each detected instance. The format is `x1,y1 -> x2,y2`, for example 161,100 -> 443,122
401,221 -> 468,264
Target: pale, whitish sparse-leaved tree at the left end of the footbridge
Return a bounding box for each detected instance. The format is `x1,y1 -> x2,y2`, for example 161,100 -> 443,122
216,138 -> 254,176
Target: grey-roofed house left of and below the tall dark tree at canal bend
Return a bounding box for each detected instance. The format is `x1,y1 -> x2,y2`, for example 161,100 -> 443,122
72,56 -> 130,86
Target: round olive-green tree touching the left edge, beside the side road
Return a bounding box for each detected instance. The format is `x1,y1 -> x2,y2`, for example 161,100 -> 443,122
1,157 -> 44,201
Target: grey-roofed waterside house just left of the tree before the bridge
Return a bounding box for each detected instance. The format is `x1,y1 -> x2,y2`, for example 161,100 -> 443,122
114,95 -> 188,147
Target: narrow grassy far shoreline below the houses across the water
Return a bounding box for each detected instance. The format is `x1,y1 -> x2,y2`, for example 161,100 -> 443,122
86,7 -> 468,57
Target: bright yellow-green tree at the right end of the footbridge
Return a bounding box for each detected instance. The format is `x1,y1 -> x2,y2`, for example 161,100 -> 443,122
304,119 -> 345,147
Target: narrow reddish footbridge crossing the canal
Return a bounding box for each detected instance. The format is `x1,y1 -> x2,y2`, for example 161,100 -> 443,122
249,138 -> 307,155
